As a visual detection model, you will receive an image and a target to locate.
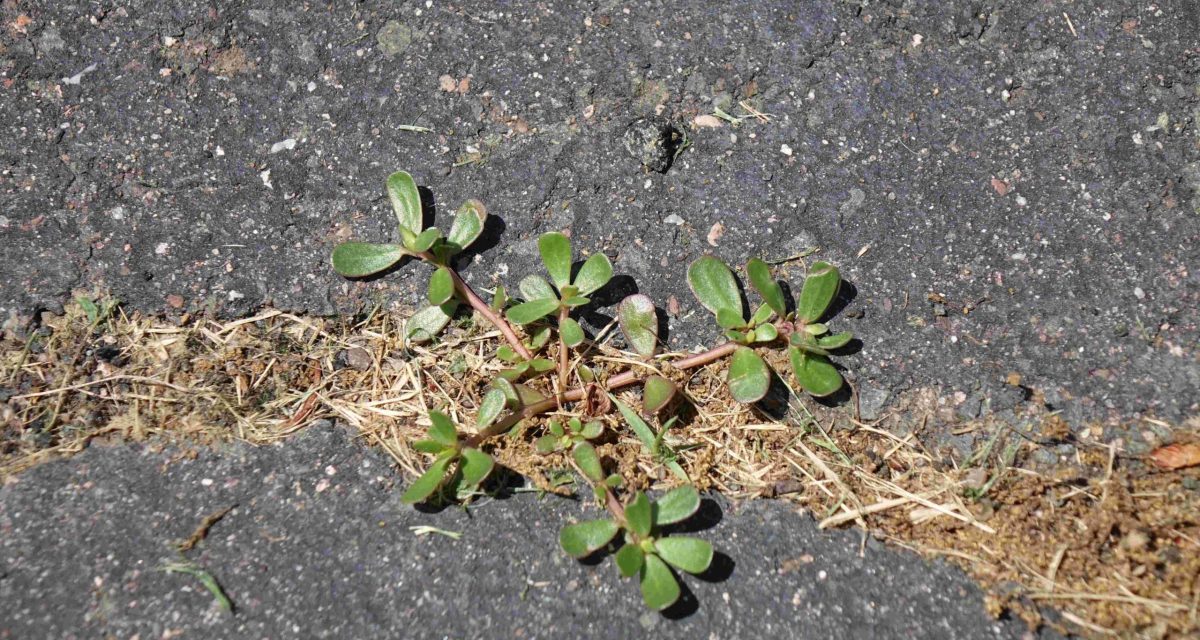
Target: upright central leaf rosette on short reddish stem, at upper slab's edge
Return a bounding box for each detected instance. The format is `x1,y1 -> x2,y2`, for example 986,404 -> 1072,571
506,232 -> 612,387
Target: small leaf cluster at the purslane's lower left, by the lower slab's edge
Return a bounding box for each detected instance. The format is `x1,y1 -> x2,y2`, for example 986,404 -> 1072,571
400,411 -> 494,504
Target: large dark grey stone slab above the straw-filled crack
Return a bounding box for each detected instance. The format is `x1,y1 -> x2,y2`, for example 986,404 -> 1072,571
0,0 -> 1200,429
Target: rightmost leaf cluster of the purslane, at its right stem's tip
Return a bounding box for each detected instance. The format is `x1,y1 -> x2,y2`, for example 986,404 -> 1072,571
688,256 -> 853,403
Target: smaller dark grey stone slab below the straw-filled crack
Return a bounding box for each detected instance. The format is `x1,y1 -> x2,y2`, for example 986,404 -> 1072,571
0,427 -> 1041,639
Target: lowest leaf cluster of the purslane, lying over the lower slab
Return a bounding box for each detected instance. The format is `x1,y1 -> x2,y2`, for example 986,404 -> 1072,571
558,485 -> 713,611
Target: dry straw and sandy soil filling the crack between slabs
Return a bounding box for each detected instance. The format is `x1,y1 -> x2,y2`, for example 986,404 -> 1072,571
0,300 -> 1200,638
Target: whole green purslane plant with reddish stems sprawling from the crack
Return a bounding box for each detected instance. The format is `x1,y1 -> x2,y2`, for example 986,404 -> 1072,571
332,172 -> 852,610
